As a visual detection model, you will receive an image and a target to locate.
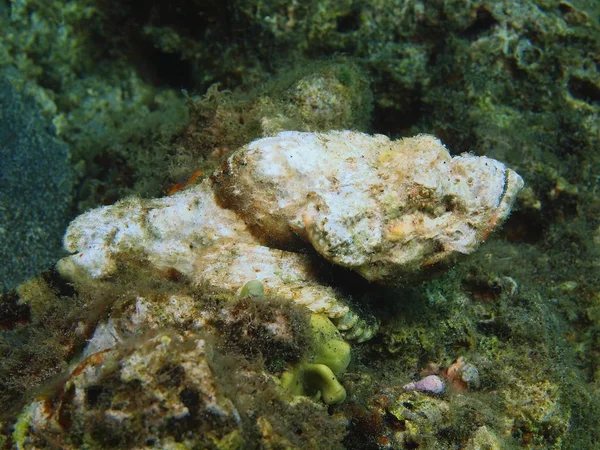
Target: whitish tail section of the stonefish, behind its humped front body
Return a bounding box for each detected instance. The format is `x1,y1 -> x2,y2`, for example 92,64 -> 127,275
58,183 -> 257,278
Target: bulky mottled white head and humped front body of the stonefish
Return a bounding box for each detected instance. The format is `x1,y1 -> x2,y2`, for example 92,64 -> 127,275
216,131 -> 523,284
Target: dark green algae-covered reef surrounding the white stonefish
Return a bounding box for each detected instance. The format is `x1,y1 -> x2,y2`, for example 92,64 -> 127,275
0,0 -> 600,449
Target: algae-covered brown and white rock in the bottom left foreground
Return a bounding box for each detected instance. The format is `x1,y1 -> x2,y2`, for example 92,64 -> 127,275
17,332 -> 343,450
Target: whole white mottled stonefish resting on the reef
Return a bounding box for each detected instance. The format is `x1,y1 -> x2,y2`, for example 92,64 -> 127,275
58,131 -> 523,340
